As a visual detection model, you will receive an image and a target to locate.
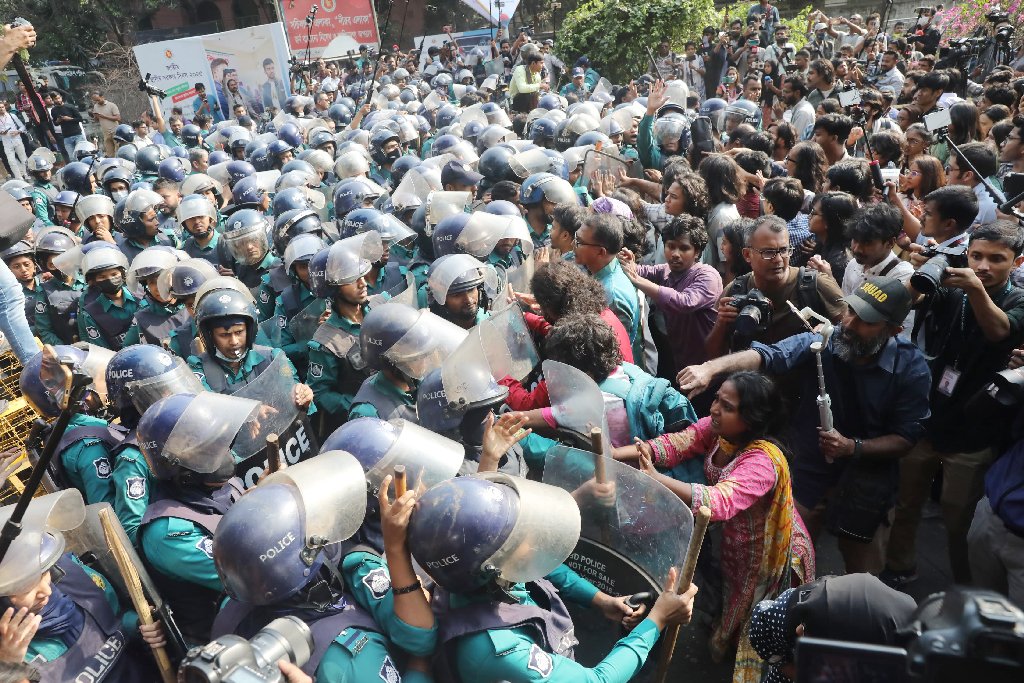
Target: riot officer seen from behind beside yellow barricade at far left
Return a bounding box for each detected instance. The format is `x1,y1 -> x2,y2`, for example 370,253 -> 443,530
18,345 -> 125,504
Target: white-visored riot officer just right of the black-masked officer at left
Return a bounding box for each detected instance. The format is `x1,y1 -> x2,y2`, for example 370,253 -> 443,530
124,247 -> 189,347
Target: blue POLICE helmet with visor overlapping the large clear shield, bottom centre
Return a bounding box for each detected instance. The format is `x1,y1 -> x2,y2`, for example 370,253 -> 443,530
409,472 -> 581,593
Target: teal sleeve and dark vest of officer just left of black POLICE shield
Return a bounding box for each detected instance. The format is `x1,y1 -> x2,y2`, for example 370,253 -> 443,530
138,478 -> 242,644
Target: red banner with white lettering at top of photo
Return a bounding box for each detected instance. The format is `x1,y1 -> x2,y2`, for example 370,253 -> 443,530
281,0 -> 380,59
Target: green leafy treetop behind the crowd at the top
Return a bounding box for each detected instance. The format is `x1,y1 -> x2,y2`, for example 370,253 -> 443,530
555,0 -> 717,83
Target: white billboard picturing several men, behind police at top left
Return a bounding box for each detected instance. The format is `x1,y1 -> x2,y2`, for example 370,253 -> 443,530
133,24 -> 291,121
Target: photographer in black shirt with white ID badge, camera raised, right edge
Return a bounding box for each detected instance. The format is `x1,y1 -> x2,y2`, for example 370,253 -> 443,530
883,220 -> 1024,587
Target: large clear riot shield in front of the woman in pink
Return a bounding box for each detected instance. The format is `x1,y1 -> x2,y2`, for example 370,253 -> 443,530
543,444 -> 693,595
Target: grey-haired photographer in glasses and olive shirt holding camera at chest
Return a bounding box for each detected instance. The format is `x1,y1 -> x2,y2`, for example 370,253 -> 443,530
707,216 -> 845,358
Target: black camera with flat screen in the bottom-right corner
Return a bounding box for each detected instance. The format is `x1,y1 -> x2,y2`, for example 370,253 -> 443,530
797,588 -> 1024,683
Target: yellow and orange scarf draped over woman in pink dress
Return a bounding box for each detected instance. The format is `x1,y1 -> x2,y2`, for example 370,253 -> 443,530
733,438 -> 814,683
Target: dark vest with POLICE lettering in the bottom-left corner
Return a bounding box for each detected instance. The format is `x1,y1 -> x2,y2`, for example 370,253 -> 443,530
29,555 -> 152,683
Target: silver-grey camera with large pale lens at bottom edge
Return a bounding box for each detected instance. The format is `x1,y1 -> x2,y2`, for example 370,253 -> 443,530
178,616 -> 313,683
